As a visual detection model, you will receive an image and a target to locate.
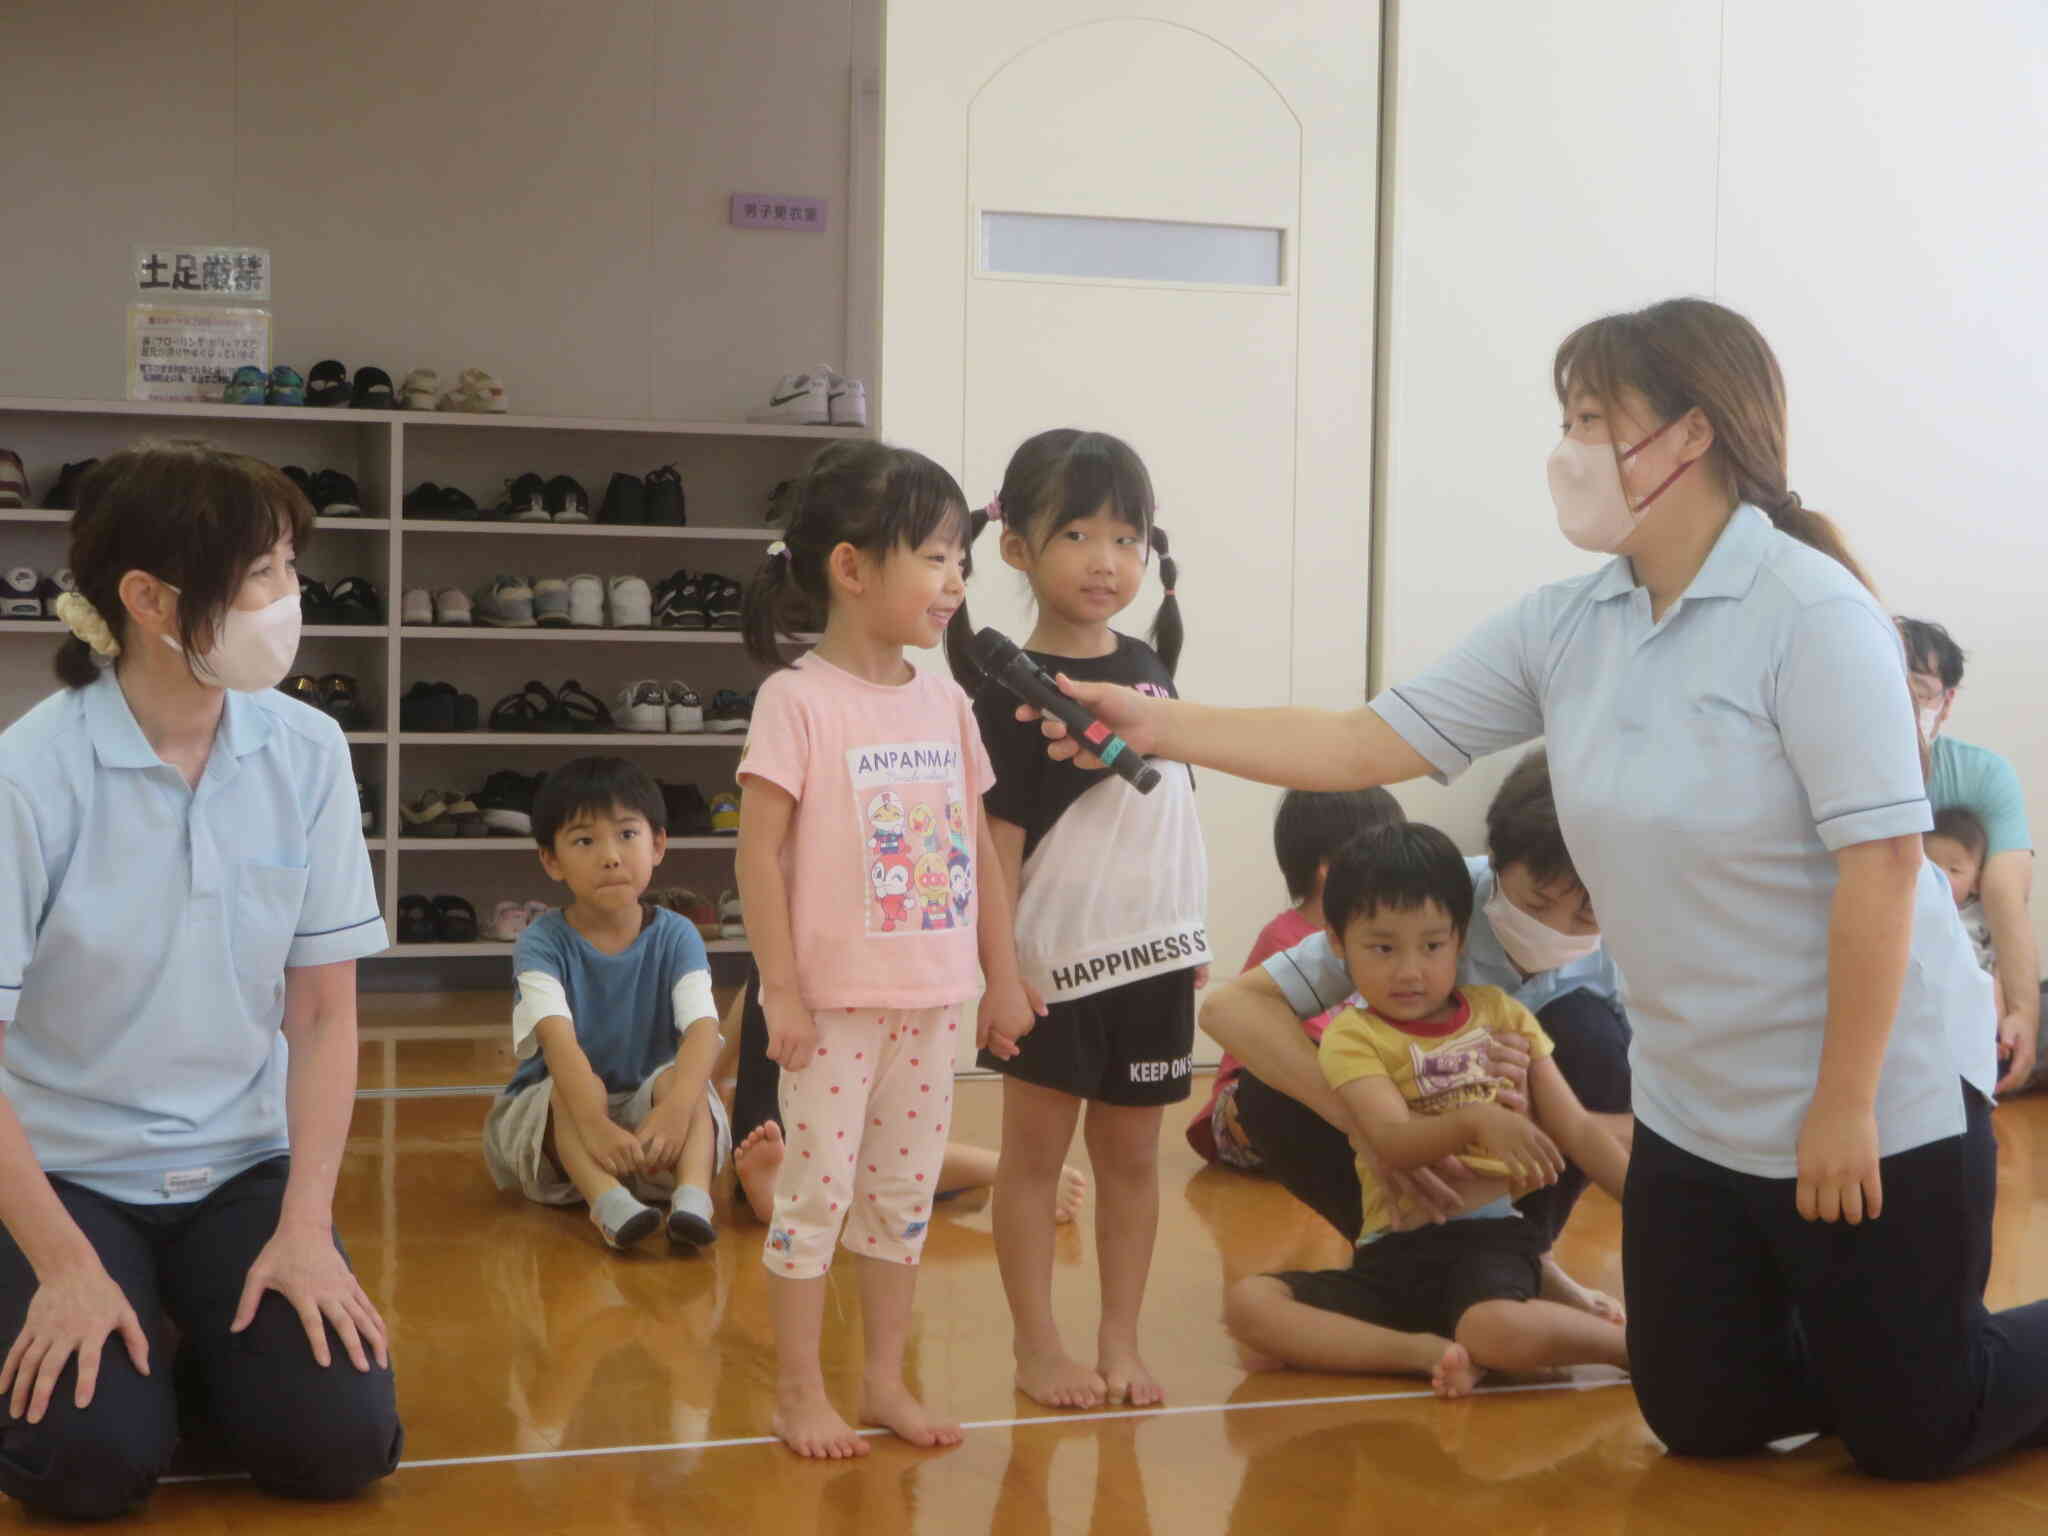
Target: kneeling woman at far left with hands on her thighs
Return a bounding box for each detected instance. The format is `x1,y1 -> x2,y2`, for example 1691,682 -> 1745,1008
0,444 -> 401,1518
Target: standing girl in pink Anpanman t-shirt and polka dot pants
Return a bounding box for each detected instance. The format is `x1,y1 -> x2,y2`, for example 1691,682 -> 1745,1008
739,442 -> 1034,1458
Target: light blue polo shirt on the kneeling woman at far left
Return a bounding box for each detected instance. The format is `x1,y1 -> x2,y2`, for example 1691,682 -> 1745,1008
0,672 -> 387,1204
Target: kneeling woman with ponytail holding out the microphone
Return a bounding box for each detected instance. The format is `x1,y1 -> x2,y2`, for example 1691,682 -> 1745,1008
1044,299 -> 2048,1477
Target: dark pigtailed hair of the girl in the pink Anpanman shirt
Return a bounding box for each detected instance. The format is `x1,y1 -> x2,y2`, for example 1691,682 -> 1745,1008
745,442 -> 969,668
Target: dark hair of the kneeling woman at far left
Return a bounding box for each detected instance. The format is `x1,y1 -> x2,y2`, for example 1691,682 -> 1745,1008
55,442 -> 313,688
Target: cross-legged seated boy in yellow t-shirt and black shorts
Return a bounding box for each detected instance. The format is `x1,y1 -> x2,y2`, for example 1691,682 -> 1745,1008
1227,821 -> 1628,1397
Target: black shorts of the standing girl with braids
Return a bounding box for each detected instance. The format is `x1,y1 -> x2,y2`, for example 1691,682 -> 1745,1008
977,967 -> 1194,1108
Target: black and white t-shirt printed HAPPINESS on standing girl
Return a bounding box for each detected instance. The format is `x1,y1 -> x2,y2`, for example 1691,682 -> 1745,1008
975,635 -> 1208,1001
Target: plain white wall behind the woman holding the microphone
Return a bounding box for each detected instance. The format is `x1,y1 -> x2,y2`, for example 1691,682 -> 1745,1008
1378,0 -> 2048,962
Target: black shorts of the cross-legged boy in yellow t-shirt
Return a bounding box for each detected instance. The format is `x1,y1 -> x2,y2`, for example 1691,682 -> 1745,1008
1274,1217 -> 1548,1339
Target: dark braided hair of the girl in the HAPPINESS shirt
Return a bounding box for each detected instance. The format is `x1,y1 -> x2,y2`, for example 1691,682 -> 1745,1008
946,426 -> 1186,688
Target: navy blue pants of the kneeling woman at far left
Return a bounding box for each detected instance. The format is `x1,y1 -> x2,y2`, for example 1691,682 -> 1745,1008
0,1157 -> 406,1520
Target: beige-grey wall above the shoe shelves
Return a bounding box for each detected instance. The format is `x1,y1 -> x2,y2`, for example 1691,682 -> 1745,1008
0,0 -> 881,420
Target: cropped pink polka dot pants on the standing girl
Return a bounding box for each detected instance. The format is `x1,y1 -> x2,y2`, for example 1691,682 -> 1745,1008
762,1008 -> 961,1280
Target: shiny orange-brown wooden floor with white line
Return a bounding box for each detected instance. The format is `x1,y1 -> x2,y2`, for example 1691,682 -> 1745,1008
16,1004 -> 2048,1536
